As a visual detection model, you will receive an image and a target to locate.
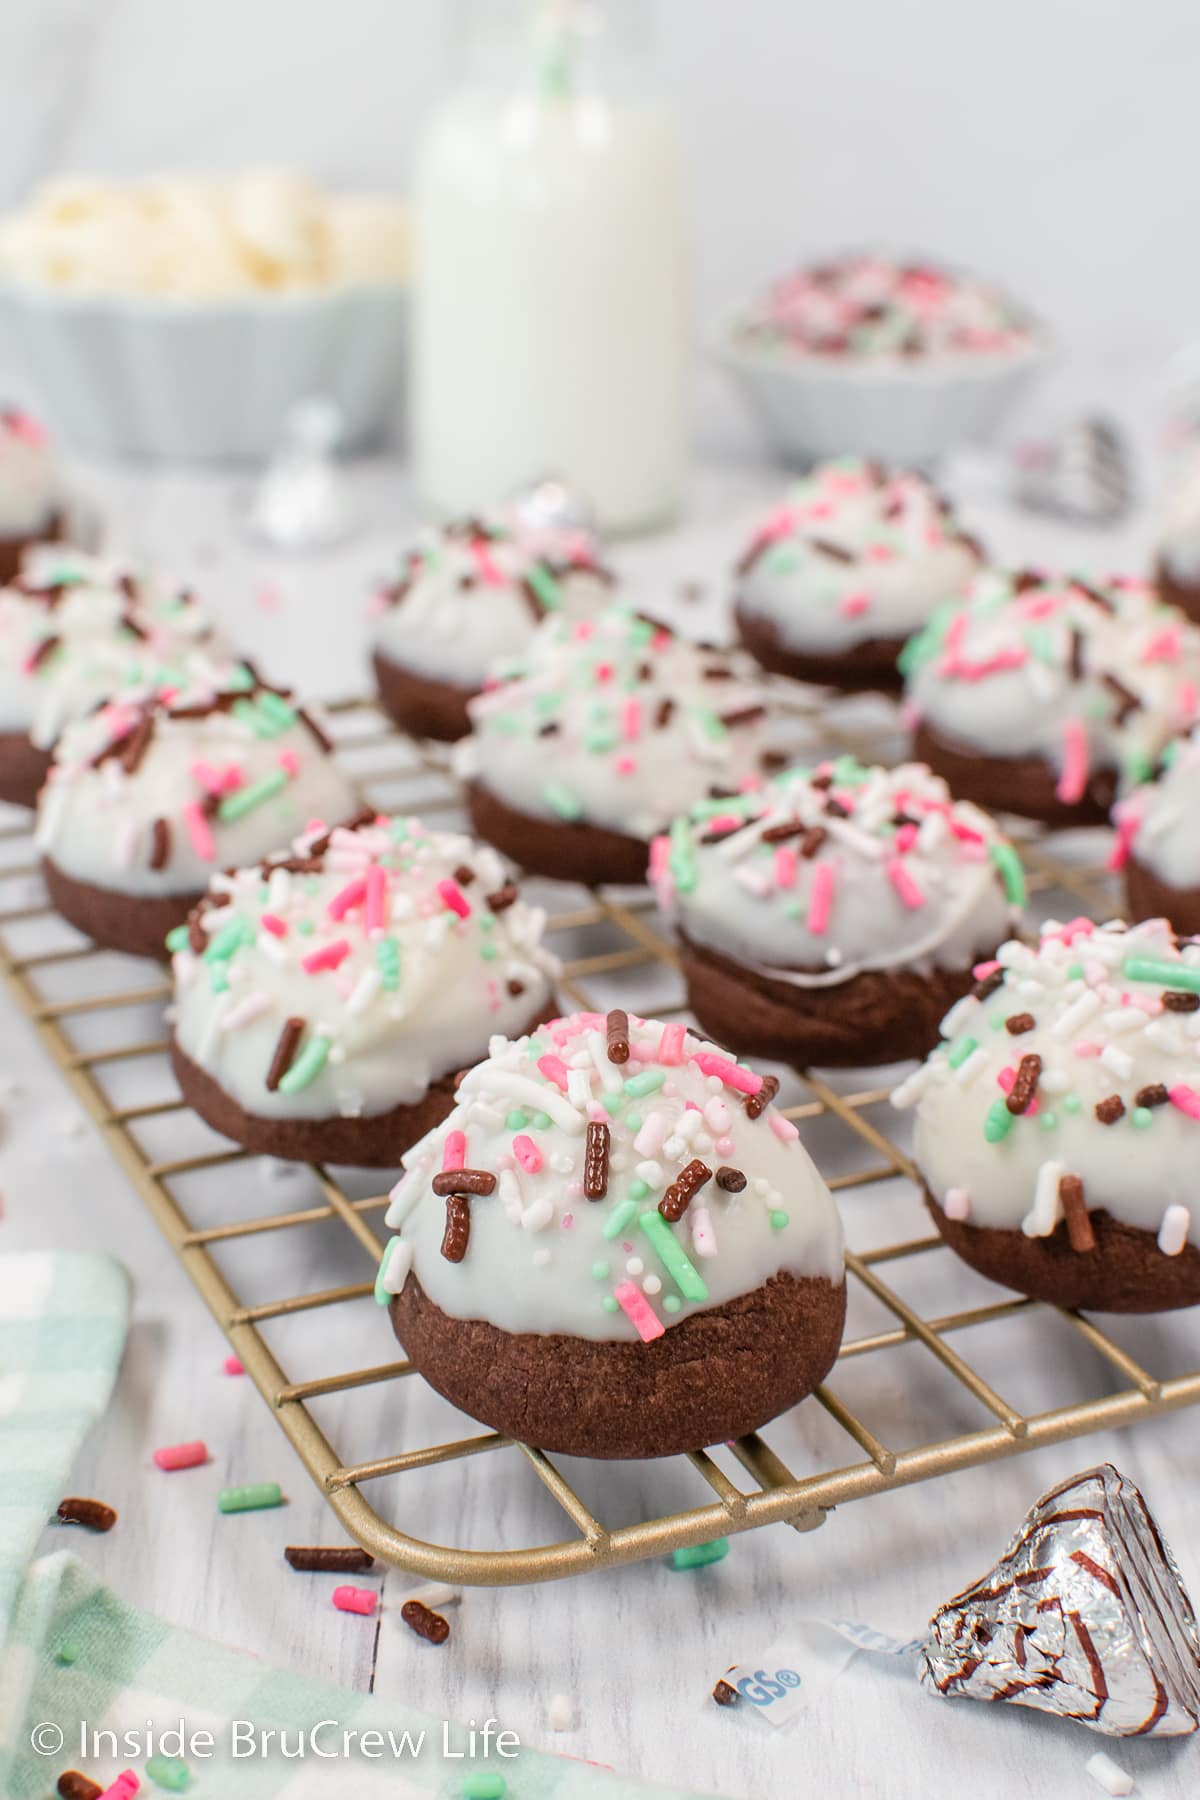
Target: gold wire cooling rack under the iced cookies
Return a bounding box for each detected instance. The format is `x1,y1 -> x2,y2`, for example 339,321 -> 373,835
0,700 -> 1200,1586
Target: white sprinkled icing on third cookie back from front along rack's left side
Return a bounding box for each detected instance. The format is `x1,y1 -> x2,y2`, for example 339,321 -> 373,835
36,664 -> 358,895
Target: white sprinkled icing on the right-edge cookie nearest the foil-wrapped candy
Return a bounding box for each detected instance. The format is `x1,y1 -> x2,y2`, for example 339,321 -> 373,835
892,920 -> 1200,1244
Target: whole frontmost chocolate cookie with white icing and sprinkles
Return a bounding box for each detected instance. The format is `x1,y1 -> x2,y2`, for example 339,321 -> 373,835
378,1013 -> 846,1456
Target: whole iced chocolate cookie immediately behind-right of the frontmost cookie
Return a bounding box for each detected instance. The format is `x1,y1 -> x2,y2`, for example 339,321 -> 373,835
651,756 -> 1025,1066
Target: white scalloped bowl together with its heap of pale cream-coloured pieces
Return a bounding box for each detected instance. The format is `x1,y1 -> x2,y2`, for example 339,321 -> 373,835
0,169 -> 408,463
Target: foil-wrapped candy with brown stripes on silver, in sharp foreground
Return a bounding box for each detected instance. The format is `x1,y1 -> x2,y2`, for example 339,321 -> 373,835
921,1463 -> 1200,1737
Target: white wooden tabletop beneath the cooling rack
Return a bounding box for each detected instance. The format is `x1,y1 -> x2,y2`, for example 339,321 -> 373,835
0,435 -> 1200,1800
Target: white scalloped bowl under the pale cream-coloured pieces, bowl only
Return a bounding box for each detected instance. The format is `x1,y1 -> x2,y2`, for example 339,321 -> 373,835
0,283 -> 408,463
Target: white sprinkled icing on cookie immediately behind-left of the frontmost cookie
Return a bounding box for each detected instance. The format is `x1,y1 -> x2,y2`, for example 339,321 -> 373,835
171,815 -> 558,1118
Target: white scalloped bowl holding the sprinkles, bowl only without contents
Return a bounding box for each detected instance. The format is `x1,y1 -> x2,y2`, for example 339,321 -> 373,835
718,331 -> 1051,468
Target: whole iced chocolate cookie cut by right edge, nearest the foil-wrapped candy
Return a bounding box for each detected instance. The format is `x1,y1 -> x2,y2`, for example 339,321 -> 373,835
892,918 -> 1200,1312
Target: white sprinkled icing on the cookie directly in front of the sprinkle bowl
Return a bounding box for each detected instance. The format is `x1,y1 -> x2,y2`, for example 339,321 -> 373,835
736,457 -> 982,655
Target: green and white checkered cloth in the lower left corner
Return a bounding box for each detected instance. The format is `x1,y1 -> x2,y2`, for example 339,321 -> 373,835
0,1255 -> 719,1800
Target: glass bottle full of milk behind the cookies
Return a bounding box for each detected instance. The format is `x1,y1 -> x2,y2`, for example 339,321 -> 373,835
412,0 -> 691,531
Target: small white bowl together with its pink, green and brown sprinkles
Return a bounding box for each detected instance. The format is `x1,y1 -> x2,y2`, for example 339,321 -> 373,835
720,252 -> 1049,466
